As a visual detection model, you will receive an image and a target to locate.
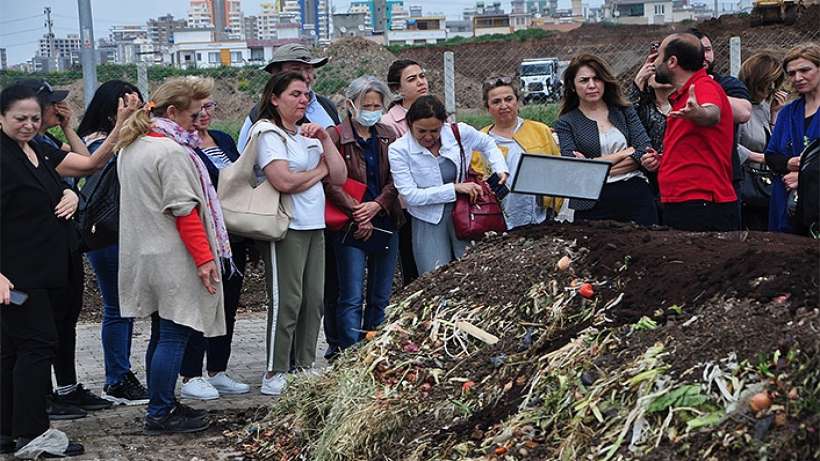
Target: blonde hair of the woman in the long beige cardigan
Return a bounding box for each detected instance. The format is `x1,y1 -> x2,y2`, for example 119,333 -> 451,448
115,77 -> 214,150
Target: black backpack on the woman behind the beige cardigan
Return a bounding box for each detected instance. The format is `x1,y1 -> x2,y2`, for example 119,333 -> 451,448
79,160 -> 120,250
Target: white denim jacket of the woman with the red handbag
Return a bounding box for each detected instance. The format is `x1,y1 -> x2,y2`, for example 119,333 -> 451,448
388,123 -> 509,224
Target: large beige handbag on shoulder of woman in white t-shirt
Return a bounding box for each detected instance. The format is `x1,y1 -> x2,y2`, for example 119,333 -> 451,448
217,119 -> 293,241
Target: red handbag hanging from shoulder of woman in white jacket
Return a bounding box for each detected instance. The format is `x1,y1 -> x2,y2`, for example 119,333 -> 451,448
450,123 -> 507,240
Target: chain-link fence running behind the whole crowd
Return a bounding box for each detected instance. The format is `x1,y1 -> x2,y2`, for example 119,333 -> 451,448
0,20 -> 820,136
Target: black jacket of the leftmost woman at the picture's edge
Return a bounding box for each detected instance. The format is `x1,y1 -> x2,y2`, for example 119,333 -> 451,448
0,129 -> 74,291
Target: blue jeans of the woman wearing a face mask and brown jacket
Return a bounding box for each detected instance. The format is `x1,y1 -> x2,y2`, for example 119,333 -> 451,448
333,232 -> 399,349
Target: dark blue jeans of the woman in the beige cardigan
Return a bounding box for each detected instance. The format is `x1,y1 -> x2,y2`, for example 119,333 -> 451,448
145,312 -> 194,418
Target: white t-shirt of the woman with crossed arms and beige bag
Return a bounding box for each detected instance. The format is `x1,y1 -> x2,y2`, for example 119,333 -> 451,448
256,130 -> 325,230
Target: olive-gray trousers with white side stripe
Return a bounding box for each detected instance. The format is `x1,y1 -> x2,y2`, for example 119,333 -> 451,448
262,229 -> 325,373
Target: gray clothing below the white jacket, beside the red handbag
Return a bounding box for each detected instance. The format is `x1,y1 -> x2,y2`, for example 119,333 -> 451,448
410,203 -> 470,275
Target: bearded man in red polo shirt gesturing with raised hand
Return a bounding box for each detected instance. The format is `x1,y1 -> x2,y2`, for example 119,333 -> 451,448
644,34 -> 738,231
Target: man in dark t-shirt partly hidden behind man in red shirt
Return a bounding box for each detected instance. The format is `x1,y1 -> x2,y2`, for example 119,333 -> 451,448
689,28 -> 752,228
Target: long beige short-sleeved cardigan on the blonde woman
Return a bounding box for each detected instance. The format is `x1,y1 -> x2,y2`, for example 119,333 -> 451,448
117,136 -> 225,337
